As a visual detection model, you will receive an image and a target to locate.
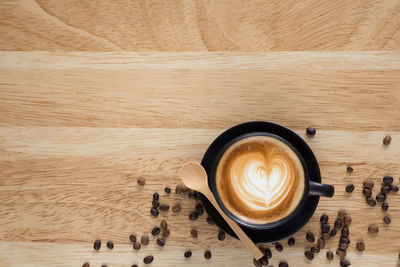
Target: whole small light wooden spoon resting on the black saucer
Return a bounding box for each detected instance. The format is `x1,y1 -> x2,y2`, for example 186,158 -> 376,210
180,162 -> 264,260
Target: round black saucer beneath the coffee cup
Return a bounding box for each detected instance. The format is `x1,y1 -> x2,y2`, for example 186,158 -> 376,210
201,121 -> 321,243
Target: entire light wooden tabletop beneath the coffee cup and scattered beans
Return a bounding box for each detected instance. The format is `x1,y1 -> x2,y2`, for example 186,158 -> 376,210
0,0 -> 400,267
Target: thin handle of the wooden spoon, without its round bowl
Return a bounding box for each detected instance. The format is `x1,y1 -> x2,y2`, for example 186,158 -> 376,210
201,188 -> 264,260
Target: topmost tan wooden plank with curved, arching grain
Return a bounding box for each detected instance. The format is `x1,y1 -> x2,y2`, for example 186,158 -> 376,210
0,0 -> 400,51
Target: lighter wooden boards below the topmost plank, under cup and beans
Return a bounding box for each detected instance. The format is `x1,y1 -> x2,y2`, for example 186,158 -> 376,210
0,52 -> 400,266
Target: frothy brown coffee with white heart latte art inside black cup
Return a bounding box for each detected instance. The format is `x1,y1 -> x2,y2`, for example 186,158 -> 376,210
216,136 -> 304,224
